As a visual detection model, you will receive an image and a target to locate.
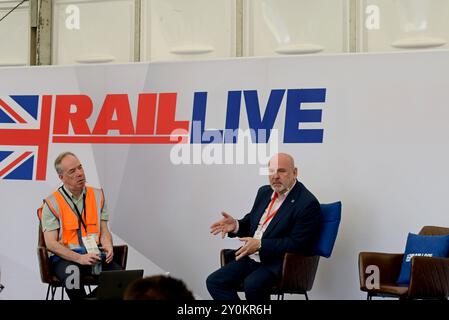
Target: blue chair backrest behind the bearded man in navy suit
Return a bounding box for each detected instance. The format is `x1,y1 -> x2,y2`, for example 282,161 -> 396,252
314,201 -> 341,258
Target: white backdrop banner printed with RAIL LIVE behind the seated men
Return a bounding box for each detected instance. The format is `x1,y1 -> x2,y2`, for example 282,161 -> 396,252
0,51 -> 449,299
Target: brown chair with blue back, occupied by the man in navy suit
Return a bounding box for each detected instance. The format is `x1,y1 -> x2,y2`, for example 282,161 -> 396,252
221,201 -> 341,300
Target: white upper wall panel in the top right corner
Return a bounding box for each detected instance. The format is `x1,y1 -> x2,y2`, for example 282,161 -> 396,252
359,0 -> 449,51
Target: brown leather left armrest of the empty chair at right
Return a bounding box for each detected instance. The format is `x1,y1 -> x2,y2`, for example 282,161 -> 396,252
359,252 -> 404,291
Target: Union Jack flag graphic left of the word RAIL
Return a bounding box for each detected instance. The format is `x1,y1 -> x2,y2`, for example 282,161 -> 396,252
0,95 -> 51,180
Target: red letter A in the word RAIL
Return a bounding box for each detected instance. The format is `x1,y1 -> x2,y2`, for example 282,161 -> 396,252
92,94 -> 134,135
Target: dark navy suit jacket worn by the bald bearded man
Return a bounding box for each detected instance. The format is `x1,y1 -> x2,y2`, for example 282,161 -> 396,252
229,181 -> 321,275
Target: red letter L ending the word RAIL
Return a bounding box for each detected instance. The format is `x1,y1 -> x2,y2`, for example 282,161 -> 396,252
156,93 -> 190,135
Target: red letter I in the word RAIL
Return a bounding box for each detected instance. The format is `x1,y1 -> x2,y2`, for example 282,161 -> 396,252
136,93 -> 157,135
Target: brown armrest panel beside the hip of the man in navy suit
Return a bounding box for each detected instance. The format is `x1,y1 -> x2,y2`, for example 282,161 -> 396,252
279,252 -> 320,292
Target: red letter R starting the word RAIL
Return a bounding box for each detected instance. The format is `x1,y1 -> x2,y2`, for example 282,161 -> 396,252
53,95 -> 93,135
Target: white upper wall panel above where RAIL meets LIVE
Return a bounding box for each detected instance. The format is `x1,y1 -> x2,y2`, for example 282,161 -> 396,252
141,0 -> 236,61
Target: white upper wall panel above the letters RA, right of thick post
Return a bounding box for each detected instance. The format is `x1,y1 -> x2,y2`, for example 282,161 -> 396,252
52,0 -> 135,64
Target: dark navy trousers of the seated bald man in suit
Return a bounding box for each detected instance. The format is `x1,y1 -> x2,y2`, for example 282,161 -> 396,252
206,257 -> 278,302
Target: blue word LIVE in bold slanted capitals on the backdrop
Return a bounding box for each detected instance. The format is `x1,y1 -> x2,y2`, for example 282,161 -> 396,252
190,88 -> 326,144
